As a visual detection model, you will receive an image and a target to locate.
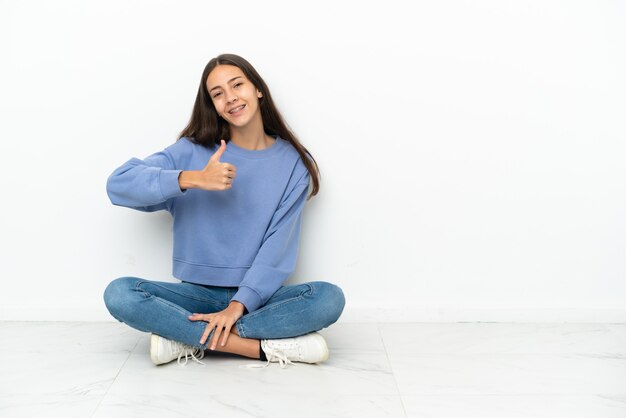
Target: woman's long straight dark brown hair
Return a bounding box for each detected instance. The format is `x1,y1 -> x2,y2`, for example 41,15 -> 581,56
178,54 -> 321,200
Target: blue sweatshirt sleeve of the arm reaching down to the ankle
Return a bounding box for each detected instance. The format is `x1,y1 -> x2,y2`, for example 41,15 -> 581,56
233,172 -> 310,312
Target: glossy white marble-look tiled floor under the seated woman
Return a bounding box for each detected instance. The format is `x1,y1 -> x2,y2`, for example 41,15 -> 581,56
0,322 -> 626,418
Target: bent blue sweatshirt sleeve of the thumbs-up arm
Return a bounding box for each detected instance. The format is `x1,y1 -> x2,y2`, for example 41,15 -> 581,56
107,149 -> 186,212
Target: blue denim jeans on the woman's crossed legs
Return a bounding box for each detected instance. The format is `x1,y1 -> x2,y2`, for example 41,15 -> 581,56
104,277 -> 345,349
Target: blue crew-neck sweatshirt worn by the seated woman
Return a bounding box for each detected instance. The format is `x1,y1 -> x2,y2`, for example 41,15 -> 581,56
107,137 -> 310,312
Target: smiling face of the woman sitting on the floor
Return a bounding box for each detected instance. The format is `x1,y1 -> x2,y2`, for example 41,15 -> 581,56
206,65 -> 261,127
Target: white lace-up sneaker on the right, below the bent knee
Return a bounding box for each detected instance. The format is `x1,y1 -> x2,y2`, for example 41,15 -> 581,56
261,332 -> 328,369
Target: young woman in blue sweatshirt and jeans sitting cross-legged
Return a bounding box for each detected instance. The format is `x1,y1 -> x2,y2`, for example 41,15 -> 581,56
104,54 -> 345,367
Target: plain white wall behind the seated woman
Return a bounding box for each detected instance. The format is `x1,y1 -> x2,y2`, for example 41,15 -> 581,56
0,0 -> 626,322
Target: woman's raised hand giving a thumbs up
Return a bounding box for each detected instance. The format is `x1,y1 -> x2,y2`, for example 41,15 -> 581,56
179,139 -> 237,190
